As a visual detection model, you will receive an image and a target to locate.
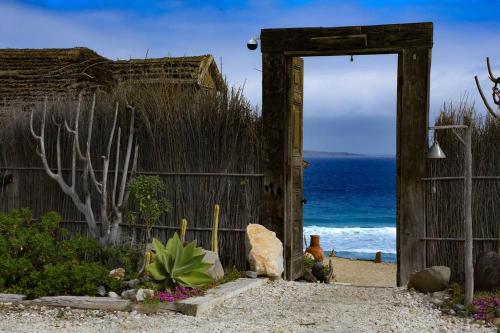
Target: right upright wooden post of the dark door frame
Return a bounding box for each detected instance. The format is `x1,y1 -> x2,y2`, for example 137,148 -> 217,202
396,48 -> 431,286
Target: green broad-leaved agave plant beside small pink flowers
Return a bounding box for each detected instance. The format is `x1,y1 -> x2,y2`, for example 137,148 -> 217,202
147,233 -> 212,288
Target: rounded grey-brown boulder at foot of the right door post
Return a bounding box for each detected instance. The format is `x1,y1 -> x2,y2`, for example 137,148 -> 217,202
408,266 -> 451,293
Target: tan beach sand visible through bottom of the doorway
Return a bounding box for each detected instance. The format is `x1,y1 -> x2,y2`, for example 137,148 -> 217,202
325,257 -> 397,287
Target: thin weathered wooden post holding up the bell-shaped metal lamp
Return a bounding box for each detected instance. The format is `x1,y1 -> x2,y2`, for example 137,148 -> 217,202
464,119 -> 474,305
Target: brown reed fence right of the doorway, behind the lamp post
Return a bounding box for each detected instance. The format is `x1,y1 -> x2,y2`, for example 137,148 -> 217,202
422,99 -> 500,282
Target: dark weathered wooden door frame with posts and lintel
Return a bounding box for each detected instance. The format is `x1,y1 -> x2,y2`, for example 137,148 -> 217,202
260,22 -> 433,285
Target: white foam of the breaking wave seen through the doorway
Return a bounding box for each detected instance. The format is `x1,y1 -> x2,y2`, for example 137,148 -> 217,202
304,226 -> 396,254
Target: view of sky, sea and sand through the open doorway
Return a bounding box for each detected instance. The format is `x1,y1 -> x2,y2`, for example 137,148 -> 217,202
303,55 -> 398,287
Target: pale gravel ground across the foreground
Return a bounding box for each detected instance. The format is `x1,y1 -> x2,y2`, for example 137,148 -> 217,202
0,281 -> 496,333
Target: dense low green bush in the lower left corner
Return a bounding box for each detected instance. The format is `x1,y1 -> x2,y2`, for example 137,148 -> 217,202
0,209 -> 139,298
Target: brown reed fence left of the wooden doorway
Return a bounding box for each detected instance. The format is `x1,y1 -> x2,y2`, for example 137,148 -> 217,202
0,83 -> 263,269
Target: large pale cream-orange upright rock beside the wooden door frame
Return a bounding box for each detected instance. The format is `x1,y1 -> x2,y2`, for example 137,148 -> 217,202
245,224 -> 284,278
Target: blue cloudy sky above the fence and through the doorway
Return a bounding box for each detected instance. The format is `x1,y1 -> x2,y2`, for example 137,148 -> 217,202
0,0 -> 500,154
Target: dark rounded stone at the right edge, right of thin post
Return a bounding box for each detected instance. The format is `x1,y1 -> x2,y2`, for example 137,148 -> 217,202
474,251 -> 500,290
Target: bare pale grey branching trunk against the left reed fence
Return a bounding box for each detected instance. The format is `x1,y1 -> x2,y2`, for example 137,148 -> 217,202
30,94 -> 138,243
